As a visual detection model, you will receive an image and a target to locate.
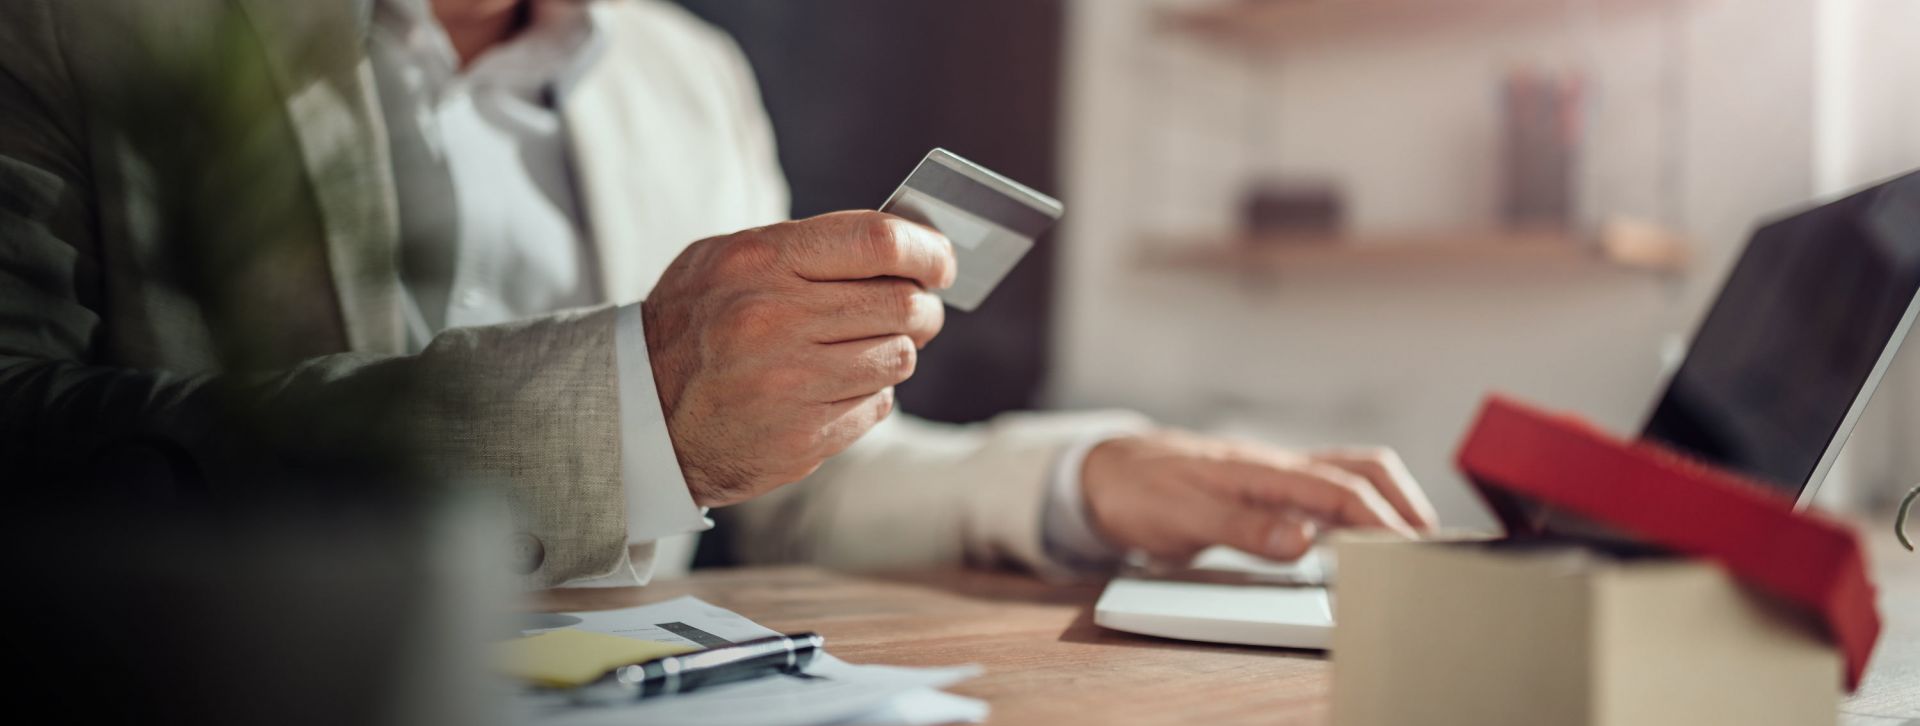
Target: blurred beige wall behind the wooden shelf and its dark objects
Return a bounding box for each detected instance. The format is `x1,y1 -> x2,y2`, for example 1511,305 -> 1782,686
1050,0 -> 1858,526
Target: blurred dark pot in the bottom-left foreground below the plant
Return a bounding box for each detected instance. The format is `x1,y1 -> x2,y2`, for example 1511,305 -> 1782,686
0,489 -> 513,726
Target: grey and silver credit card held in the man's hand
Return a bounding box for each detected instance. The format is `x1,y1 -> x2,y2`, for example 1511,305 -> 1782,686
879,148 -> 1066,311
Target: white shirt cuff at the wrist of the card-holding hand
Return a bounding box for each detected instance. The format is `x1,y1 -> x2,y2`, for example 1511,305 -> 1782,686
614,303 -> 714,545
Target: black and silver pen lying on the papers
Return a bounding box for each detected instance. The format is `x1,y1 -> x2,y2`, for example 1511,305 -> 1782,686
574,632 -> 826,701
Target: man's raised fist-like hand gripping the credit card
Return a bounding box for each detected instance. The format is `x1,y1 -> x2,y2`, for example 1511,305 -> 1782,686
641,211 -> 956,505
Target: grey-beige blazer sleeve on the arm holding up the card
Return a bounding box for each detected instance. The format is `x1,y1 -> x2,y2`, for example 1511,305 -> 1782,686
0,0 -> 626,586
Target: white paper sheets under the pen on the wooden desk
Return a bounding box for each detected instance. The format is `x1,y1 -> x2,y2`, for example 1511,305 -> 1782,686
522,597 -> 987,726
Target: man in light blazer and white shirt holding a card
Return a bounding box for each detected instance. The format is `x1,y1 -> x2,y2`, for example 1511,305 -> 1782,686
0,0 -> 1434,586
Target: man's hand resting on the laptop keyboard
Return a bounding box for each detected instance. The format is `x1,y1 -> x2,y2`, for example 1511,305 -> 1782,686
1081,432 -> 1436,561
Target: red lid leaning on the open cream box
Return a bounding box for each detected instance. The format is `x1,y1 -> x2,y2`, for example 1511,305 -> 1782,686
1459,396 -> 1880,691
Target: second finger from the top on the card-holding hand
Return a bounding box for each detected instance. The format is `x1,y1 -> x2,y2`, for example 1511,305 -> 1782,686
808,277 -> 947,348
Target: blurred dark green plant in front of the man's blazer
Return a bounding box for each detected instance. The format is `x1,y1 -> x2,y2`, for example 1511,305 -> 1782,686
88,2 -> 424,492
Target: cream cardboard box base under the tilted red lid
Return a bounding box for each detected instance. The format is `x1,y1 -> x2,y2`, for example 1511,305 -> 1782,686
1332,536 -> 1845,726
